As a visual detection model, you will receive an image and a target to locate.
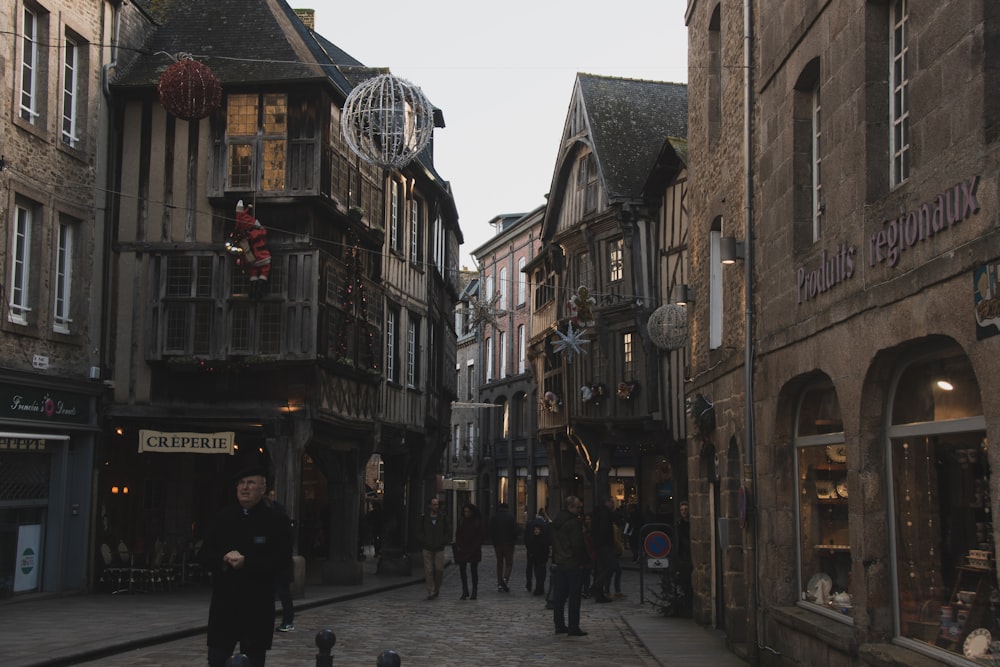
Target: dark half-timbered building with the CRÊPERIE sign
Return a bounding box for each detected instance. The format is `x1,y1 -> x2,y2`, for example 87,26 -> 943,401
100,0 -> 461,583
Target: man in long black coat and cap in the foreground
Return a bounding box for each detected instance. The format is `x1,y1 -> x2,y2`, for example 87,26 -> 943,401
203,467 -> 292,667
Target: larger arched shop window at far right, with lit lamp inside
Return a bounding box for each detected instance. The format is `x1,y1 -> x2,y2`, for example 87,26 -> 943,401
888,347 -> 988,657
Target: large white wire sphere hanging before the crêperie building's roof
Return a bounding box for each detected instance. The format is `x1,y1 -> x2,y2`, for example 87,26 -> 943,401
341,74 -> 434,169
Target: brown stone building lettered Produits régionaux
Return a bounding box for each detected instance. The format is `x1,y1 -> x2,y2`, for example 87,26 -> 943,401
687,0 -> 1000,665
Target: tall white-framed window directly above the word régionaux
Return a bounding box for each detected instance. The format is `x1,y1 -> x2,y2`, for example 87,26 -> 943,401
889,0 -> 910,187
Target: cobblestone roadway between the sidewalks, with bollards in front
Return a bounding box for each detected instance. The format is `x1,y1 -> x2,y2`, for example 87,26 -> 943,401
72,561 -> 660,667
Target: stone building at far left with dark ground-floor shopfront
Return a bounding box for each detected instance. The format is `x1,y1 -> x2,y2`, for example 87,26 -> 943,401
0,0 -> 113,598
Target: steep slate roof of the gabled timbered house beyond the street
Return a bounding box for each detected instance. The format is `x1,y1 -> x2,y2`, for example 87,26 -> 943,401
577,73 -> 687,201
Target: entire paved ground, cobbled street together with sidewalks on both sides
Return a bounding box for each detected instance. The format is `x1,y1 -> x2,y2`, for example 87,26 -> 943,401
0,548 -> 746,667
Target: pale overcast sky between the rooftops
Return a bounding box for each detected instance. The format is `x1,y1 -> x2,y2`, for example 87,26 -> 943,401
312,0 -> 687,268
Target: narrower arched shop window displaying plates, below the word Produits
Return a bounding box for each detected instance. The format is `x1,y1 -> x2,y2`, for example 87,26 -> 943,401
795,380 -> 851,622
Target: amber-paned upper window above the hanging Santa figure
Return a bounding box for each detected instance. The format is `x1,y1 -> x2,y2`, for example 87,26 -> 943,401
226,93 -> 288,192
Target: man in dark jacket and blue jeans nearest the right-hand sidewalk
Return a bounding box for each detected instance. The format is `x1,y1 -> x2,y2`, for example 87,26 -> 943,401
552,496 -> 587,637
